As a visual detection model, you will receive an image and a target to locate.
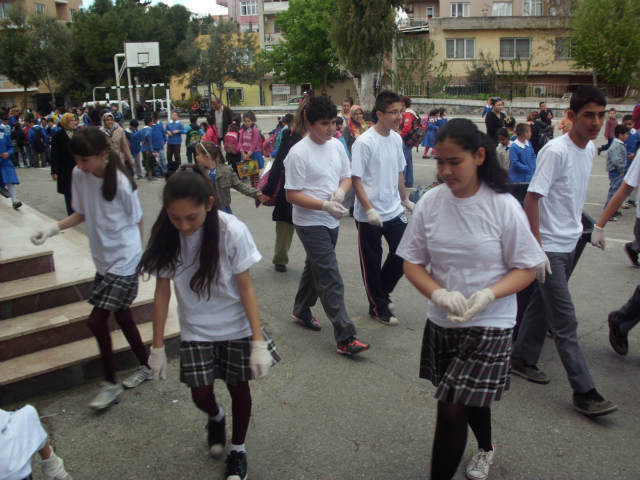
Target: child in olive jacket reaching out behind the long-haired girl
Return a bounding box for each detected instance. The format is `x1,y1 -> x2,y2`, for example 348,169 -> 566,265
196,141 -> 269,214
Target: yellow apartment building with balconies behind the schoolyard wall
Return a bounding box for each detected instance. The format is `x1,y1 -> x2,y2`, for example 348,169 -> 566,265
400,0 -> 592,84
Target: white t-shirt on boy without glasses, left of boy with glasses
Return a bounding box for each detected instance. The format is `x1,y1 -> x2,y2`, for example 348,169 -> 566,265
284,136 -> 351,228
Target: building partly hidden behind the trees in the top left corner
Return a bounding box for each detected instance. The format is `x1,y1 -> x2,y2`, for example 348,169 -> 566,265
0,0 -> 82,108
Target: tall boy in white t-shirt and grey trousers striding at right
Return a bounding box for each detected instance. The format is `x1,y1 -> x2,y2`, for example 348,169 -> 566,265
511,87 -> 618,416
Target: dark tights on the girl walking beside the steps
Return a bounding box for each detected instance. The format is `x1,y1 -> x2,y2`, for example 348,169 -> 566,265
87,307 -> 149,383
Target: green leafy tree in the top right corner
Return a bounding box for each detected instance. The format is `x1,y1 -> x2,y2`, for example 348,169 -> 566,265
567,0 -> 640,85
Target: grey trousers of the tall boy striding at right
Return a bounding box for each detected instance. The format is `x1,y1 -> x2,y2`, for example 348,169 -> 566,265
512,252 -> 596,393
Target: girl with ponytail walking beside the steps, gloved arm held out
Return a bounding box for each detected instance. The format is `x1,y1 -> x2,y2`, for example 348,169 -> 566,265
31,128 -> 152,410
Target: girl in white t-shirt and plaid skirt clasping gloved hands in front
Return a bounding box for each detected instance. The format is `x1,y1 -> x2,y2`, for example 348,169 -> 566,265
396,119 -> 545,480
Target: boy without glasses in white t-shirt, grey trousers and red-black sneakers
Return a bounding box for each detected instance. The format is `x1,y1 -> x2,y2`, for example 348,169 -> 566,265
284,97 -> 369,355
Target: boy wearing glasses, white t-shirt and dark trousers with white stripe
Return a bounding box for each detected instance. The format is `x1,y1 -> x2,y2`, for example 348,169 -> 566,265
351,92 -> 414,326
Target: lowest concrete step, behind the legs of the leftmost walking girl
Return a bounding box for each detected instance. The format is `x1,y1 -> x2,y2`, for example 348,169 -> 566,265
0,308 -> 180,406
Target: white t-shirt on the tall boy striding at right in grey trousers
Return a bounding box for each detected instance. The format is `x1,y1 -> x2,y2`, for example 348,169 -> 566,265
529,135 -> 596,253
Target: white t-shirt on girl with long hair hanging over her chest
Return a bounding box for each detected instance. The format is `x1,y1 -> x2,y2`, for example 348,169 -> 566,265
158,212 -> 262,342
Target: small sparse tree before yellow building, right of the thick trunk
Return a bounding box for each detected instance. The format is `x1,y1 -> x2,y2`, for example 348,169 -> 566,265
386,38 -> 451,96
